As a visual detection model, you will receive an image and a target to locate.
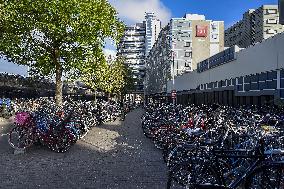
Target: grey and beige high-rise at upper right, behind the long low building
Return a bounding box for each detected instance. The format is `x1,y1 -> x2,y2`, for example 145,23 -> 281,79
225,5 -> 284,48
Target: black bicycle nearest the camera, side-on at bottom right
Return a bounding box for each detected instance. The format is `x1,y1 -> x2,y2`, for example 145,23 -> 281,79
167,140 -> 284,189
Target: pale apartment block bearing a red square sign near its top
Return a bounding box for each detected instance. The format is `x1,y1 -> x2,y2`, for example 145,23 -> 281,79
169,14 -> 224,76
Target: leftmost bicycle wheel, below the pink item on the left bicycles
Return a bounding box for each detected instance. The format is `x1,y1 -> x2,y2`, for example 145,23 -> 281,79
8,126 -> 33,150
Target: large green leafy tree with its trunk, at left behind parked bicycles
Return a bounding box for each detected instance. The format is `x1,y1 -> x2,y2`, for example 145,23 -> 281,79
0,0 -> 124,105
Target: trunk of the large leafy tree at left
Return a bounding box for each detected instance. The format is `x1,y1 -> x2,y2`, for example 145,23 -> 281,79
54,50 -> 62,106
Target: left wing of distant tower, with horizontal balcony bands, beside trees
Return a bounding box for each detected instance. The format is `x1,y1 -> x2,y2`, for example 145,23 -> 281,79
117,22 -> 146,92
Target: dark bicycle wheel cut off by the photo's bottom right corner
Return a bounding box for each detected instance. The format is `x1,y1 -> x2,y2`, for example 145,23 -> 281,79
245,162 -> 284,189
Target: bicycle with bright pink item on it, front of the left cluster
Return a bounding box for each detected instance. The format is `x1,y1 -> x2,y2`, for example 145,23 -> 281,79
8,112 -> 76,152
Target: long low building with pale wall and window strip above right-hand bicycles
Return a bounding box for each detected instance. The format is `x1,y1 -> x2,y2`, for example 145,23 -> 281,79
164,33 -> 284,105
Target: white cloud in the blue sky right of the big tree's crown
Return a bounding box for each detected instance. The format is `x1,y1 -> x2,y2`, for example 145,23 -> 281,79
109,0 -> 172,25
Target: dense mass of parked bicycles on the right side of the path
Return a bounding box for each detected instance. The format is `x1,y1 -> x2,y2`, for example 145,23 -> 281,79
142,104 -> 284,189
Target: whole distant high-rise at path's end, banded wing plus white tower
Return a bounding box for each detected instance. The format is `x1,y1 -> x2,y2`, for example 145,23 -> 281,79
117,13 -> 161,93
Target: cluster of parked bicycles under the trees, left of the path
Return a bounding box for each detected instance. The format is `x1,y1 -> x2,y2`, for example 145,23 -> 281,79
8,98 -> 121,152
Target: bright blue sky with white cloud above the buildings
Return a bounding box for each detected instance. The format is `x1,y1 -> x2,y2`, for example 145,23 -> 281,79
0,0 -> 278,75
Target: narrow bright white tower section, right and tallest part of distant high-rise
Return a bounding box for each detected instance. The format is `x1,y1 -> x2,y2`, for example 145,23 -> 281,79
145,13 -> 161,56
